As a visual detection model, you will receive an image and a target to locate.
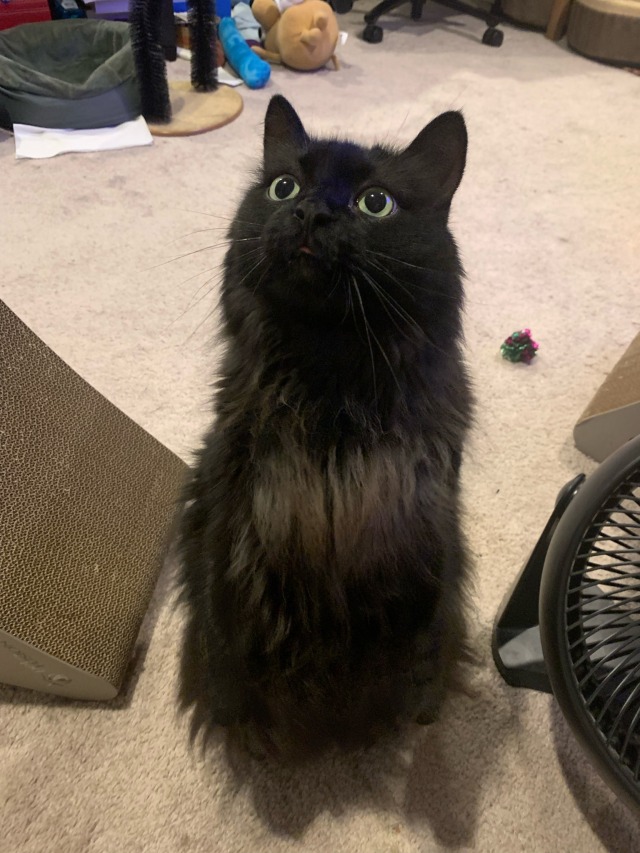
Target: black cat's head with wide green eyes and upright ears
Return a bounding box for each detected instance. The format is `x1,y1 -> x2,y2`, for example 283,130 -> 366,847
227,95 -> 467,327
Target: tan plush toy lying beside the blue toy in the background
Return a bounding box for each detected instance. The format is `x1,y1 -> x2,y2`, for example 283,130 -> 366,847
251,0 -> 339,71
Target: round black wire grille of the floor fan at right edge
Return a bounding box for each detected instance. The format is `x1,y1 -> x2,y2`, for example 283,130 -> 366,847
566,466 -> 640,783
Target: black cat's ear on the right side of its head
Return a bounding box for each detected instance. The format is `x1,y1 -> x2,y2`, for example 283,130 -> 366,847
399,111 -> 467,207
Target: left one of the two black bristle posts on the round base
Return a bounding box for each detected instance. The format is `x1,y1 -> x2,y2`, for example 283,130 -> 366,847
129,0 -> 171,124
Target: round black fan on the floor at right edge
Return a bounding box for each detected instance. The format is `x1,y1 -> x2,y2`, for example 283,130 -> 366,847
493,436 -> 640,810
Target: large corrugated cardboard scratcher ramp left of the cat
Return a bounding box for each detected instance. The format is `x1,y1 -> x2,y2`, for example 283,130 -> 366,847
0,301 -> 186,700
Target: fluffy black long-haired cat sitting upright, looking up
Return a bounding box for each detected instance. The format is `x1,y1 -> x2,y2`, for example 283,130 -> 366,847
181,96 -> 471,758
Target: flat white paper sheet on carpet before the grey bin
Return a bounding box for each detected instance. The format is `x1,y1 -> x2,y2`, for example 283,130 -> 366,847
13,116 -> 153,160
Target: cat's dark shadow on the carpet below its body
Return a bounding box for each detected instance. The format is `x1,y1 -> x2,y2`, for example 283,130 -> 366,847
203,636 -> 517,850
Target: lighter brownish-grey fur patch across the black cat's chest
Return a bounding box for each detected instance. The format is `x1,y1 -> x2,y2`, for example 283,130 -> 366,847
251,436 -> 412,573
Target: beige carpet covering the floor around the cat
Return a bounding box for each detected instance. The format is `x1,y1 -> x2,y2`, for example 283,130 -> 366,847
0,0 -> 640,853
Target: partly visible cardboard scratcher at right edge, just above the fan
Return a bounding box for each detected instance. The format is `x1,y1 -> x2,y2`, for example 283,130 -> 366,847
573,334 -> 640,462
